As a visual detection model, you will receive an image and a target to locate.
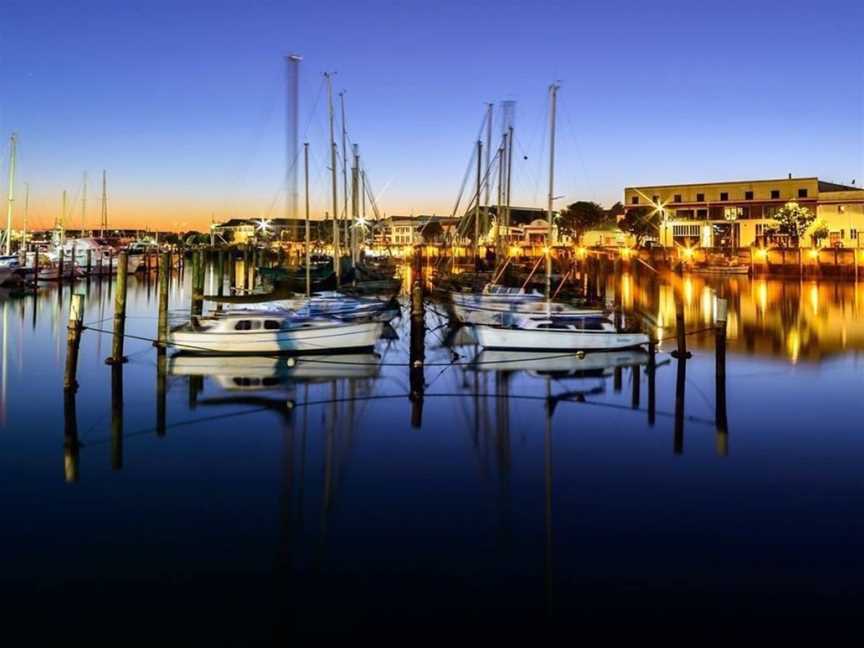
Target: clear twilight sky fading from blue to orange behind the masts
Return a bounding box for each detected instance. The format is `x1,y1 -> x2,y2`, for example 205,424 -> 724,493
0,0 -> 864,229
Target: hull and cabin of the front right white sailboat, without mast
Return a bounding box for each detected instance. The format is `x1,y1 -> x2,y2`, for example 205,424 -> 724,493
475,313 -> 648,352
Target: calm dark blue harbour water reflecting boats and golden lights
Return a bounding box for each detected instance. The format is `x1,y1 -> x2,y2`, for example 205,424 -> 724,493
0,266 -> 864,644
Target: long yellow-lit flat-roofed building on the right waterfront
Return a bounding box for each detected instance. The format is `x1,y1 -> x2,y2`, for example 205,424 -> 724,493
624,175 -> 864,248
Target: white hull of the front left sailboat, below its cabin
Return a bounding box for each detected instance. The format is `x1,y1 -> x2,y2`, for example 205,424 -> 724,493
168,322 -> 384,354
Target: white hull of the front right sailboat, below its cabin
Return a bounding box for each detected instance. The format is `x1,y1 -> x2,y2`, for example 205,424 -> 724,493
475,326 -> 648,351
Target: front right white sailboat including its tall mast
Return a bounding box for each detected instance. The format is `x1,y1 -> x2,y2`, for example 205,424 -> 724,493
475,83 -> 648,351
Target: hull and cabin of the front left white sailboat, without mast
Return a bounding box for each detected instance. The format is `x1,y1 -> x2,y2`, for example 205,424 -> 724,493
168,311 -> 384,354
